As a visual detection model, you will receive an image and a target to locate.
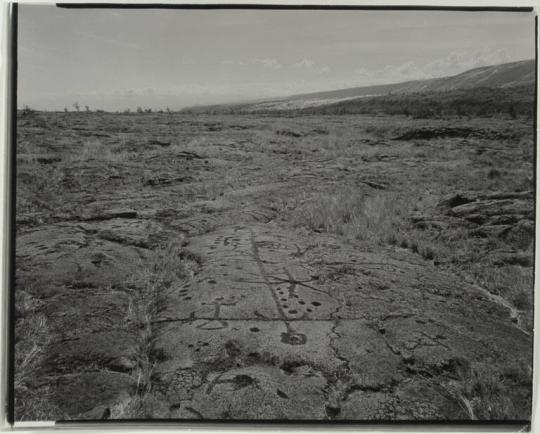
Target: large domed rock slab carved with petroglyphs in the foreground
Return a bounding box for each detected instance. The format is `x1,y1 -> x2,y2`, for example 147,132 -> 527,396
149,223 -> 530,420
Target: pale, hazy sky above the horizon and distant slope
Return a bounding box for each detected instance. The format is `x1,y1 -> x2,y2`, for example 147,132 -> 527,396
18,4 -> 534,110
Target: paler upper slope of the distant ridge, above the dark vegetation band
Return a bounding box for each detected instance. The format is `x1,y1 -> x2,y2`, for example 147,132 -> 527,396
182,59 -> 535,112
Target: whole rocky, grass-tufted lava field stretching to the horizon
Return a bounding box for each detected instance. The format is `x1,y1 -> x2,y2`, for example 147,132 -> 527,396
15,113 -> 534,421
